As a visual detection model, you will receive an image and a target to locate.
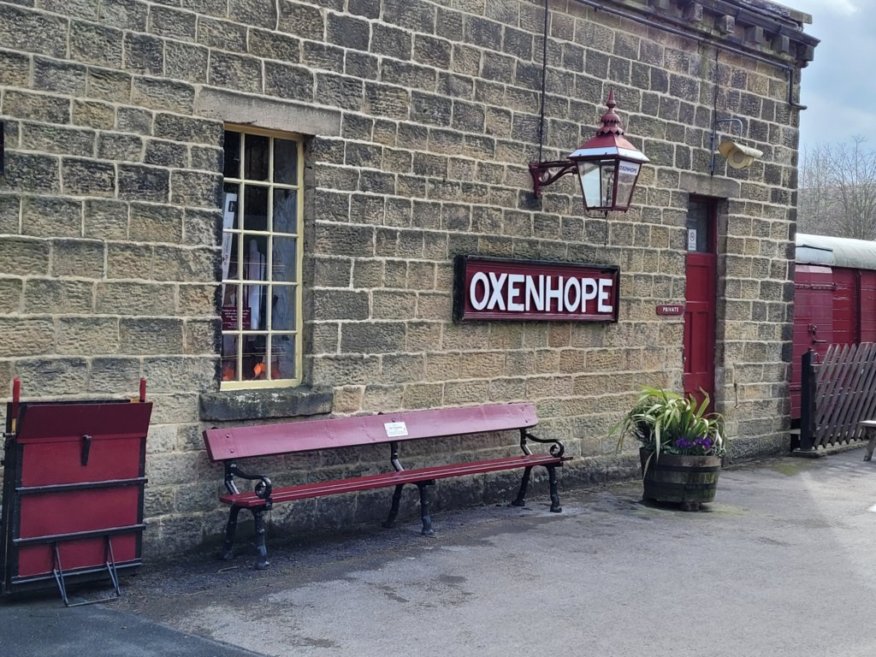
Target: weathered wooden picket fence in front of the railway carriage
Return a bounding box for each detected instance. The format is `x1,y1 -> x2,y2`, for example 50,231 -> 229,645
799,342 -> 876,451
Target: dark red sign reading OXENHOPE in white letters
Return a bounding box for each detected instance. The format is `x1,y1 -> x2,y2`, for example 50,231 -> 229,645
453,256 -> 620,322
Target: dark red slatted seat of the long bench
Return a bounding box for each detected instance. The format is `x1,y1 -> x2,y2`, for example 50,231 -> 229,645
219,454 -> 568,508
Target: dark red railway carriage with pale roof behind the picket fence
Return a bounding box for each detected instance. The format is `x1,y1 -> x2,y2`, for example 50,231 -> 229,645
790,233 -> 876,422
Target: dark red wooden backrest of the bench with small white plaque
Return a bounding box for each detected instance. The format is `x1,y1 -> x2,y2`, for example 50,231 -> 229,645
204,403 -> 538,461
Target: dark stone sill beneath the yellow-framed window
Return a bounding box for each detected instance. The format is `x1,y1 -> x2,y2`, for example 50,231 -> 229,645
200,386 -> 333,422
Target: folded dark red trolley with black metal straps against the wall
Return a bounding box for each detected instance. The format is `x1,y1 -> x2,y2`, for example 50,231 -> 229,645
2,398 -> 152,602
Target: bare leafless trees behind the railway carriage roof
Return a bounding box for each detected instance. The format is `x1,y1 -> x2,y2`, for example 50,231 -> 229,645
797,137 -> 876,240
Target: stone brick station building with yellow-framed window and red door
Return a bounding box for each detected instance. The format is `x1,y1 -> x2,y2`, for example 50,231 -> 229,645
0,0 -> 817,555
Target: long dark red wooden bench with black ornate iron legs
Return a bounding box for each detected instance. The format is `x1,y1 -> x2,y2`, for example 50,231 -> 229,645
204,403 -> 569,570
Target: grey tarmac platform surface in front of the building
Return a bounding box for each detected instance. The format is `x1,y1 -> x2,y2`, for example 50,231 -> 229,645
0,448 -> 876,657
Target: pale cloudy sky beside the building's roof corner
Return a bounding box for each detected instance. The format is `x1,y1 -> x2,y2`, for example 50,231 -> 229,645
778,0 -> 876,150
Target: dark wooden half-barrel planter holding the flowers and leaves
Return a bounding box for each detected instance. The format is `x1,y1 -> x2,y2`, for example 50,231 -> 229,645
639,449 -> 721,511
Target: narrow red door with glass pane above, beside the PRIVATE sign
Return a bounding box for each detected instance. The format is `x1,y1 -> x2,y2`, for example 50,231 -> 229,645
684,199 -> 717,400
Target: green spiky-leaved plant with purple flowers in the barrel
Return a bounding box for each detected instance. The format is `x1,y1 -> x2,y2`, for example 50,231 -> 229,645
611,386 -> 724,459
